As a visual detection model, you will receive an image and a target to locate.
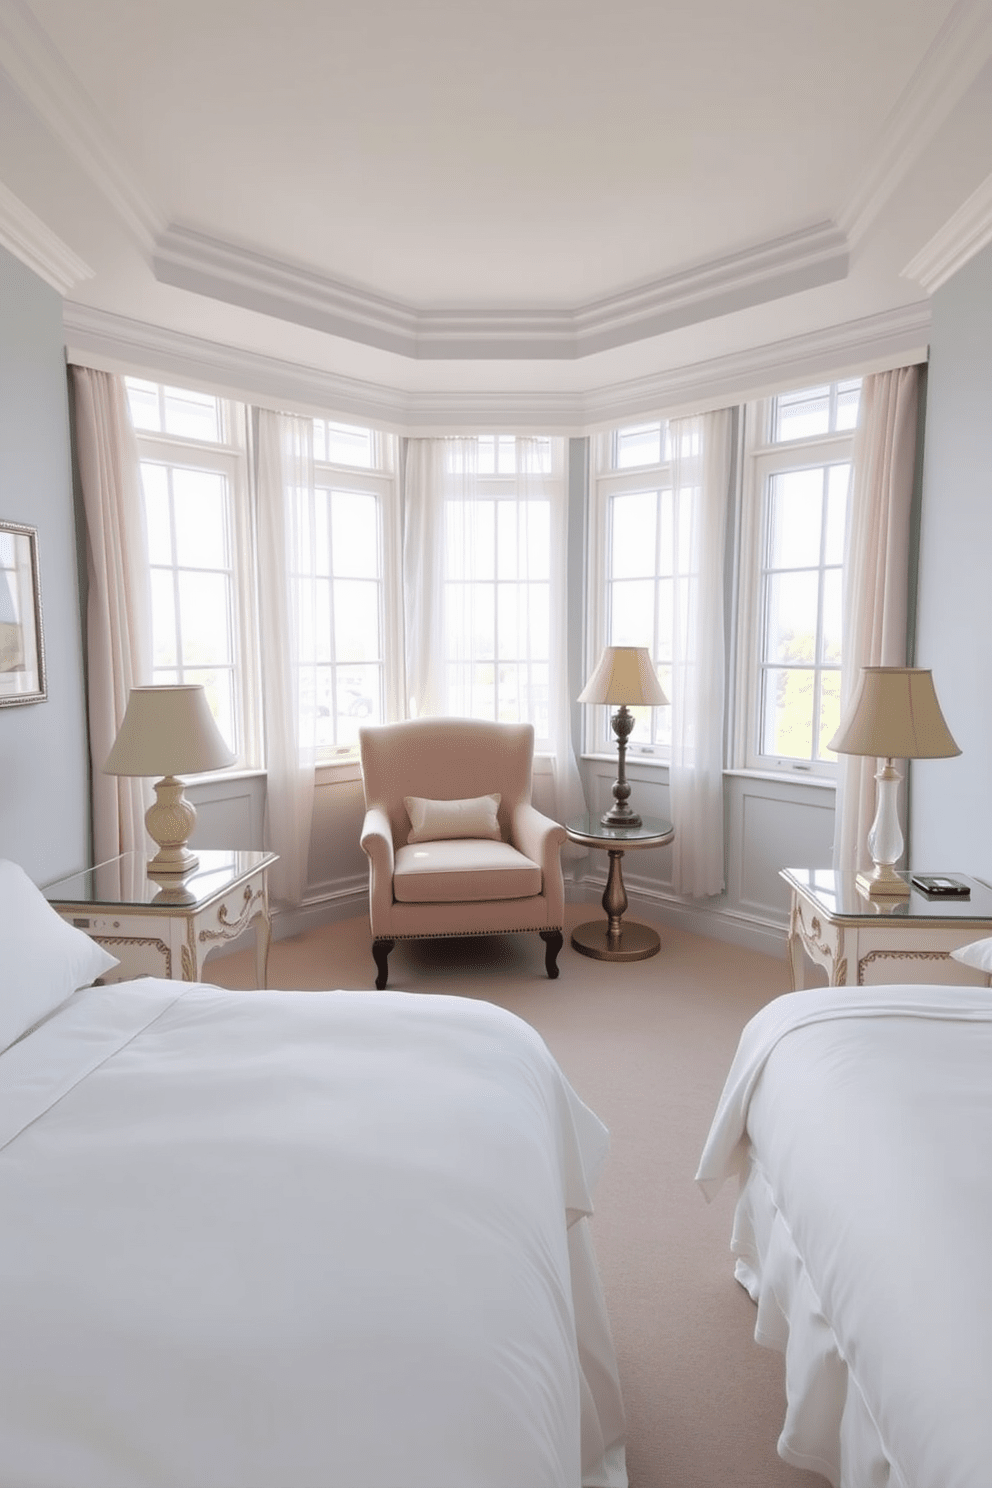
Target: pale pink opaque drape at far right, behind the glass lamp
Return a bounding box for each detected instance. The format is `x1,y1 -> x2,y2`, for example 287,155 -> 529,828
834,366 -> 919,869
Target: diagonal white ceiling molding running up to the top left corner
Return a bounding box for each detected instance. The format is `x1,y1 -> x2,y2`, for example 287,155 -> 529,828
0,0 -> 164,256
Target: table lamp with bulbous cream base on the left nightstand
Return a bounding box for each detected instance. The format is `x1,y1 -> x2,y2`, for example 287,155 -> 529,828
104,684 -> 235,879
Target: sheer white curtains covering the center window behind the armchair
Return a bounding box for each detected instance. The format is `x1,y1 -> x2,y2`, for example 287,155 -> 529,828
403,437 -> 584,820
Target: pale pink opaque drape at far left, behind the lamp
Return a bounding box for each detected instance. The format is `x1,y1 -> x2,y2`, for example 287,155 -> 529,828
70,366 -> 152,863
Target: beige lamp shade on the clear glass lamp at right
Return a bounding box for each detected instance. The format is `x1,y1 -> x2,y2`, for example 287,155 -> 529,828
828,667 -> 961,759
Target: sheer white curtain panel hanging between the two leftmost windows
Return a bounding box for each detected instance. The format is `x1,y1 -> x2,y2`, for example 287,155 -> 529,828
257,409 -> 321,905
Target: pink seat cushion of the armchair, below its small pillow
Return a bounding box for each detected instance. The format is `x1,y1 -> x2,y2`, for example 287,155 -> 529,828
393,838 -> 541,905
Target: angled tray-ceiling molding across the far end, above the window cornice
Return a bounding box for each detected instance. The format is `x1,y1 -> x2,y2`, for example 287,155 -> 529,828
152,223 -> 848,362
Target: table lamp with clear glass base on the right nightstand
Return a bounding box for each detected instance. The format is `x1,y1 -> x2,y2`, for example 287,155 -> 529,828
827,667 -> 961,899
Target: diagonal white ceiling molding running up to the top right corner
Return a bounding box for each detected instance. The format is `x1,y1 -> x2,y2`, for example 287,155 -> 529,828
837,0 -> 992,248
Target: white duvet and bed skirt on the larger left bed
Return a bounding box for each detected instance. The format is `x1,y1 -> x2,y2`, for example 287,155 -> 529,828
0,981 -> 626,1488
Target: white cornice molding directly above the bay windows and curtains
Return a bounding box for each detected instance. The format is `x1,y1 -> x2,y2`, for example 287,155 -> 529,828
64,301 -> 930,434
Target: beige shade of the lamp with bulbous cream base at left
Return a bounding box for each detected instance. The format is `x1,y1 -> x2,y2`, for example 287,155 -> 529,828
104,686 -> 235,775
